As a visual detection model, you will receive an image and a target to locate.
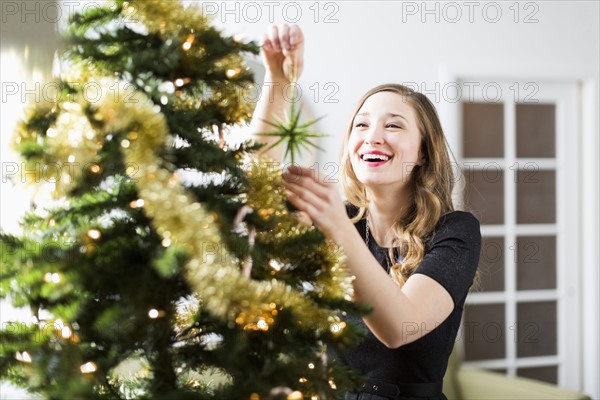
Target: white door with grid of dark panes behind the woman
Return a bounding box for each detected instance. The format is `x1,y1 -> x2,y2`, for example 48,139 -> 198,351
457,79 -> 582,389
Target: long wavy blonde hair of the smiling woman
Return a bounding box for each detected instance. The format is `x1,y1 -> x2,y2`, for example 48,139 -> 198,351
340,84 -> 455,286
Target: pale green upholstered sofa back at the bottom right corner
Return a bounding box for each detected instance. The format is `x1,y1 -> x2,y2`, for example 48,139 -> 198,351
444,348 -> 590,400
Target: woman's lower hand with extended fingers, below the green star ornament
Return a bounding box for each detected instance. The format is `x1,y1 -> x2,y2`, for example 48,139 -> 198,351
282,165 -> 354,242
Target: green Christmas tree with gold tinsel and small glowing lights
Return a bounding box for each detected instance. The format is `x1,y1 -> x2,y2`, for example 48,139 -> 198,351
0,0 -> 363,400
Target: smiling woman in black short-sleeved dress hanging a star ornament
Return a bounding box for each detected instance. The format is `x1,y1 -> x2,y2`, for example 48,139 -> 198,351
252,25 -> 481,400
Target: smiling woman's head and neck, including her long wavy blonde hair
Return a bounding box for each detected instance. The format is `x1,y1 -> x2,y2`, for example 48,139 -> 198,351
341,84 -> 455,284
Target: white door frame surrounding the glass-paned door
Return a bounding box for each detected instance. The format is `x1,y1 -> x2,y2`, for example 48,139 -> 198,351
436,64 -> 600,398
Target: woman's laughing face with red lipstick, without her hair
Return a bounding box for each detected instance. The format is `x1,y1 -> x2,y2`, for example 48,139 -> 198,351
348,92 -> 423,190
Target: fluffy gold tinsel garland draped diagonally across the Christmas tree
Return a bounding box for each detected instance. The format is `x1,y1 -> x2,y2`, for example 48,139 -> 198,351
23,74 -> 351,330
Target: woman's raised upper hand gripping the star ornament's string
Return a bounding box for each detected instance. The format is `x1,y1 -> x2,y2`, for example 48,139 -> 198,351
262,24 -> 304,82
